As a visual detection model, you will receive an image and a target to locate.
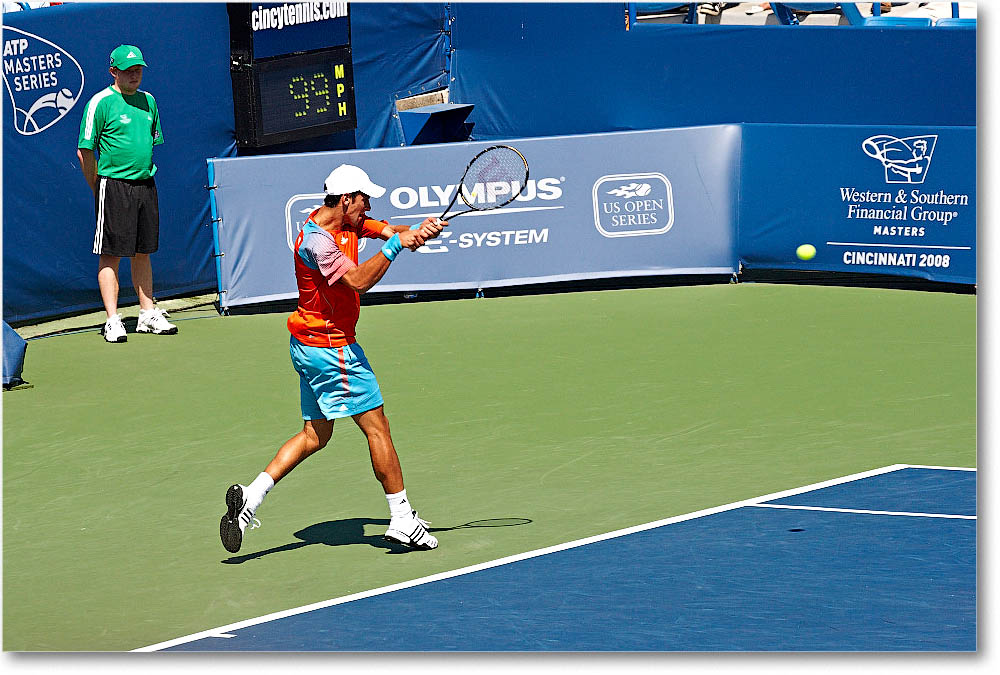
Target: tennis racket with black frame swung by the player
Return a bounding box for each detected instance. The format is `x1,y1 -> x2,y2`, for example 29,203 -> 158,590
439,145 -> 528,220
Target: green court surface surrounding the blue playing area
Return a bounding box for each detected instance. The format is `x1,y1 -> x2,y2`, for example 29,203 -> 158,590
3,284 -> 976,651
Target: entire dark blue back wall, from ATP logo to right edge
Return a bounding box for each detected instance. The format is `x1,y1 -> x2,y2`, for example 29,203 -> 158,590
0,2 -> 976,323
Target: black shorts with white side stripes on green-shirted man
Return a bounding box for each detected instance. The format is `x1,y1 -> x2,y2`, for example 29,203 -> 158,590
94,176 -> 160,258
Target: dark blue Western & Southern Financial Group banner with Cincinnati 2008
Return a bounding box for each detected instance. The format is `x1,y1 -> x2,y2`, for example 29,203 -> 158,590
738,125 -> 976,284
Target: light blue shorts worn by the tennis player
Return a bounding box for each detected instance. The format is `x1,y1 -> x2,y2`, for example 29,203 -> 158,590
288,336 -> 382,420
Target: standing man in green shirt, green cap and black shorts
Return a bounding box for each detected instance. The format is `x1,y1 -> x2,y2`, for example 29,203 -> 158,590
76,45 -> 177,342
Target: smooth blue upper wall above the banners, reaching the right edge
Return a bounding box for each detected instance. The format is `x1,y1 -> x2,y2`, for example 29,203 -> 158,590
451,3 -> 976,140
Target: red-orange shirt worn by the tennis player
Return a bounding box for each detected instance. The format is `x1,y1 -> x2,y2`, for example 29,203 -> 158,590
288,209 -> 386,347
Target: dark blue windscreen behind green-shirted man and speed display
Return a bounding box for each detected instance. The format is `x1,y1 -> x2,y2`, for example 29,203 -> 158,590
0,2 -> 449,323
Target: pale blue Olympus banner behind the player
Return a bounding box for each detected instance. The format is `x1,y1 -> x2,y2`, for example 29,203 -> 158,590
210,126 -> 740,308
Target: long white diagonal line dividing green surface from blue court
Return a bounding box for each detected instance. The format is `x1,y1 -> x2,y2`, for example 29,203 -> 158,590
132,464 -> 960,652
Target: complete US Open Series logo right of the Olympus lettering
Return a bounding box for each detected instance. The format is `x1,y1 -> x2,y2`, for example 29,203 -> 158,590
594,173 -> 674,237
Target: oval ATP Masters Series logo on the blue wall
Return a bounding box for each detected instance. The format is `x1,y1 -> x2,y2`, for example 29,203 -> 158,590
3,26 -> 84,136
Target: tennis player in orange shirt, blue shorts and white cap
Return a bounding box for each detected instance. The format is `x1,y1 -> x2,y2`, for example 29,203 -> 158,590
225,164 -> 448,553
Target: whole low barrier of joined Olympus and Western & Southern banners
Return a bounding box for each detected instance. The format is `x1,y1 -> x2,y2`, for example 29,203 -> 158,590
209,125 -> 976,309
